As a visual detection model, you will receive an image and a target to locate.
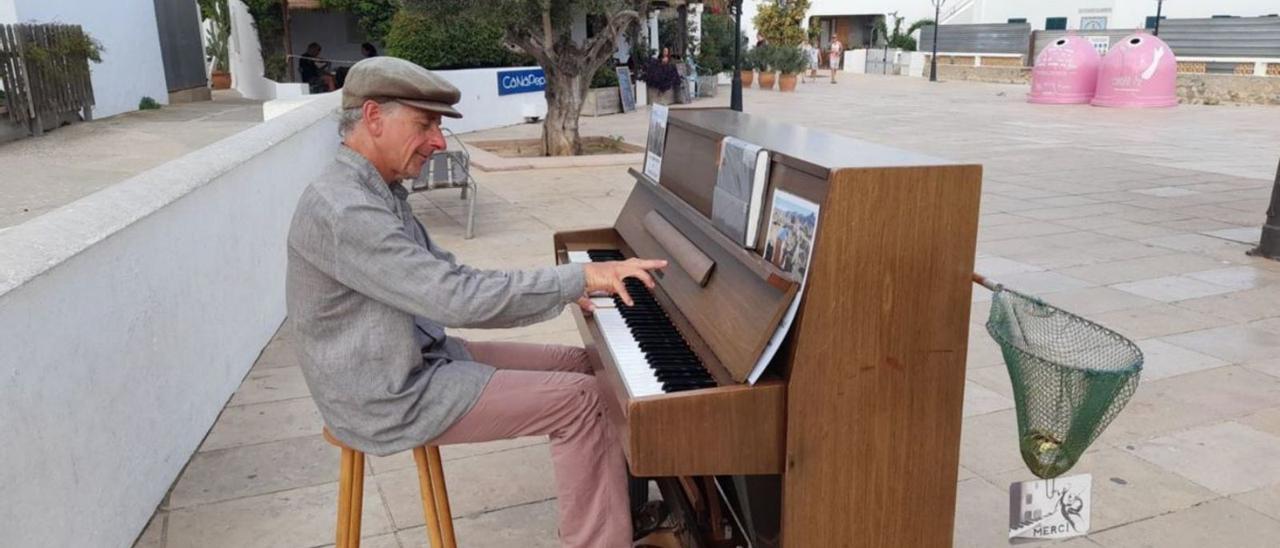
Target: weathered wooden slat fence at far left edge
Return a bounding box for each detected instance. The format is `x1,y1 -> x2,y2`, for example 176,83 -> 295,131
0,23 -> 97,134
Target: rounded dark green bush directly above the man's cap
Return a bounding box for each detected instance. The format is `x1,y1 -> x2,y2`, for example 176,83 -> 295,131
387,10 -> 532,69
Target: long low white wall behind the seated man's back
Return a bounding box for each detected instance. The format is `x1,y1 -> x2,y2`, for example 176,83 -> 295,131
0,96 -> 338,547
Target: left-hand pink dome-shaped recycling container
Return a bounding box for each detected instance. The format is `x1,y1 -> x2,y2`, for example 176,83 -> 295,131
1027,35 -> 1102,105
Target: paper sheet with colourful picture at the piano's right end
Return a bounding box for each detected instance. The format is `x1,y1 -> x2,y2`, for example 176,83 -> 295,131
746,189 -> 818,384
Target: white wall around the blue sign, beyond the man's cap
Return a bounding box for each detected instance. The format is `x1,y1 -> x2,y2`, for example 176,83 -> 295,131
435,67 -> 547,133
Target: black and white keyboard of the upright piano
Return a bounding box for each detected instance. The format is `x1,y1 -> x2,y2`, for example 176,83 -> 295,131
583,250 -> 716,397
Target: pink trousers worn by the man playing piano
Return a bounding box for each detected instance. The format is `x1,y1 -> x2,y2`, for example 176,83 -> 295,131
430,342 -> 631,548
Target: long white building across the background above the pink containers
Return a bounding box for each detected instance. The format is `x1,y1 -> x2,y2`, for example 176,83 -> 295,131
744,0 -> 1280,49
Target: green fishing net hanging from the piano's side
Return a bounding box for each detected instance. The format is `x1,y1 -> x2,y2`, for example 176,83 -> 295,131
987,287 -> 1142,479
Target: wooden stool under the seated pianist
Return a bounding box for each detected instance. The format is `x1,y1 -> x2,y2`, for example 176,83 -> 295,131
324,428 -> 457,548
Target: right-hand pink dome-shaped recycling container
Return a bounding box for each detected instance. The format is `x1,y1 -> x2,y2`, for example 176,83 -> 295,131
1093,32 -> 1178,108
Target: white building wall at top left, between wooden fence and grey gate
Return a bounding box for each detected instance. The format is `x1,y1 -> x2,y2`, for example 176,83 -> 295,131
13,0 -> 169,118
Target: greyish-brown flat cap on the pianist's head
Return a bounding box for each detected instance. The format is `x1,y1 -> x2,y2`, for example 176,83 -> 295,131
342,56 -> 462,118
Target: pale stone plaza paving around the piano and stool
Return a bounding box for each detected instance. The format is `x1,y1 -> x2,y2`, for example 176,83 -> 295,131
137,76 -> 1280,548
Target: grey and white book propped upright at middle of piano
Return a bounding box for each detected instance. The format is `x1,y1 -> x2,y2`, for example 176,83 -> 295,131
712,137 -> 769,248
